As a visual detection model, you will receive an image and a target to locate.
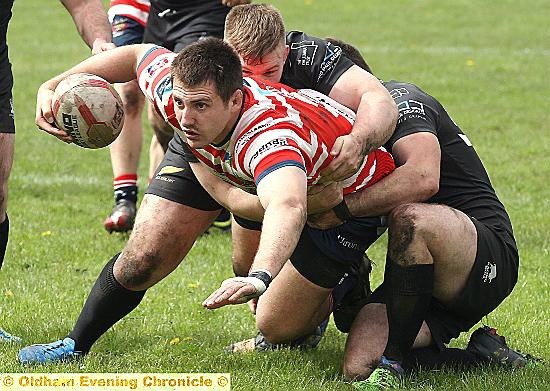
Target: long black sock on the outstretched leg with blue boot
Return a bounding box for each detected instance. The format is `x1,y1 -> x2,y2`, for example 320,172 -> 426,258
69,254 -> 145,353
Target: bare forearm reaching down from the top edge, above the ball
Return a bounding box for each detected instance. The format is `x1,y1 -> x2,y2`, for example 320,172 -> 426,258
62,0 -> 112,48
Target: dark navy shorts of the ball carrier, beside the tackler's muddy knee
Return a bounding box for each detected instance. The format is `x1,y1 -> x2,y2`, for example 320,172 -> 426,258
290,217 -> 384,288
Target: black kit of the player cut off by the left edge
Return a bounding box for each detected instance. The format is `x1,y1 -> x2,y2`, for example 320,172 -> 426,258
0,1 -> 15,133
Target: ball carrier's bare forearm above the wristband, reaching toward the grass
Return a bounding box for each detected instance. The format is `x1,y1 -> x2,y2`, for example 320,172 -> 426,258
250,203 -> 306,277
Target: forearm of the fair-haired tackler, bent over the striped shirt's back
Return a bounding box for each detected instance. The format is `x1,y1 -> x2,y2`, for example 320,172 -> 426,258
351,92 -> 398,155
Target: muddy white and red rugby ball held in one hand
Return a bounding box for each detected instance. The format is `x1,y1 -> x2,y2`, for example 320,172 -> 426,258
52,73 -> 124,149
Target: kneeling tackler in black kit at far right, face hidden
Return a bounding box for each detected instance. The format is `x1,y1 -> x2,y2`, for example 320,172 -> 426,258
310,39 -> 535,390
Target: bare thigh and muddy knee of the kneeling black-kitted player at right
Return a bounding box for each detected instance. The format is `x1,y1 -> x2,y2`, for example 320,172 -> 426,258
388,204 -> 477,302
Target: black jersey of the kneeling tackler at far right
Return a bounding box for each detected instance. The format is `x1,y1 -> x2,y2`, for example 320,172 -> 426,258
383,80 -> 515,246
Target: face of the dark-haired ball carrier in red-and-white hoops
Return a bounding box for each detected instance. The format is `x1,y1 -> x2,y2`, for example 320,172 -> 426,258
173,79 -> 242,148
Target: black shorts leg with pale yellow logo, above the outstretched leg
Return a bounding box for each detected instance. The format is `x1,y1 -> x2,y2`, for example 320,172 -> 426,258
145,135 -> 222,211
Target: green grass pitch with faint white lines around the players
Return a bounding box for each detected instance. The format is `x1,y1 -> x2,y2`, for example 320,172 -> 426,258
0,0 -> 550,391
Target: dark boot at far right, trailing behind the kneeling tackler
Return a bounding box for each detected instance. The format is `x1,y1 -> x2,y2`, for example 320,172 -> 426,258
466,326 -> 542,368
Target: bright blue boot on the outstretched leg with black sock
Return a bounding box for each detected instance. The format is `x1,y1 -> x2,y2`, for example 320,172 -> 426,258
17,337 -> 83,364
